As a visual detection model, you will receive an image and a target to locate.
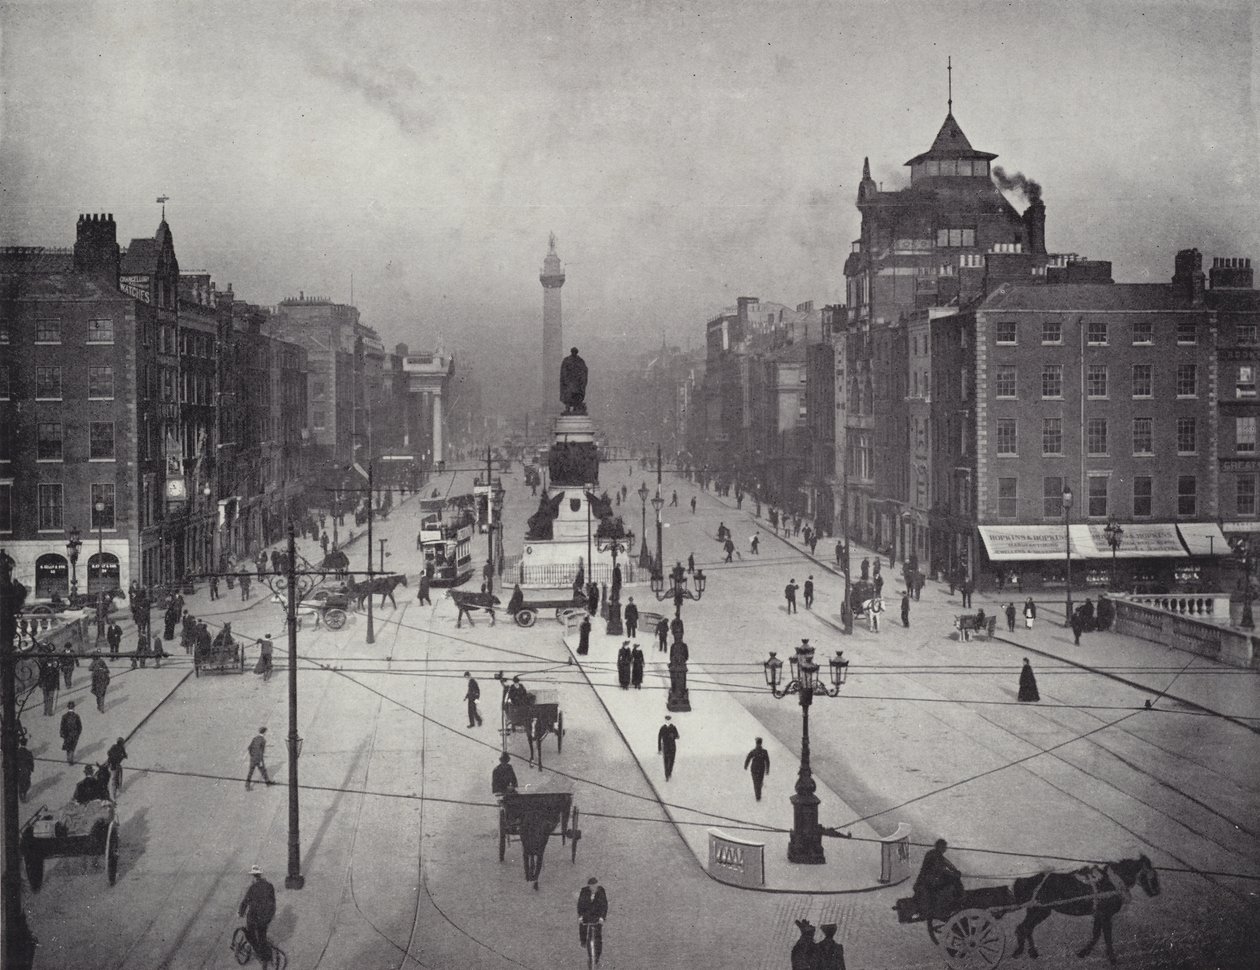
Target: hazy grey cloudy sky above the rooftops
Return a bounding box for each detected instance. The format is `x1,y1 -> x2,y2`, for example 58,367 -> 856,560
0,0 -> 1260,408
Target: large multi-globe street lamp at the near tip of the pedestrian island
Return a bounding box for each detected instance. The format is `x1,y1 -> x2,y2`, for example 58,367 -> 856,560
762,640 -> 849,865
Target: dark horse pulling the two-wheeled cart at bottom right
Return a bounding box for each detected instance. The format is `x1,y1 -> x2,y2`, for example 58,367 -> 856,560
1011,855 -> 1159,964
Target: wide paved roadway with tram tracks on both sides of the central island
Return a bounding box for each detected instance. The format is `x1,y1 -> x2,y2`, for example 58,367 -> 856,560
19,465 -> 1260,969
